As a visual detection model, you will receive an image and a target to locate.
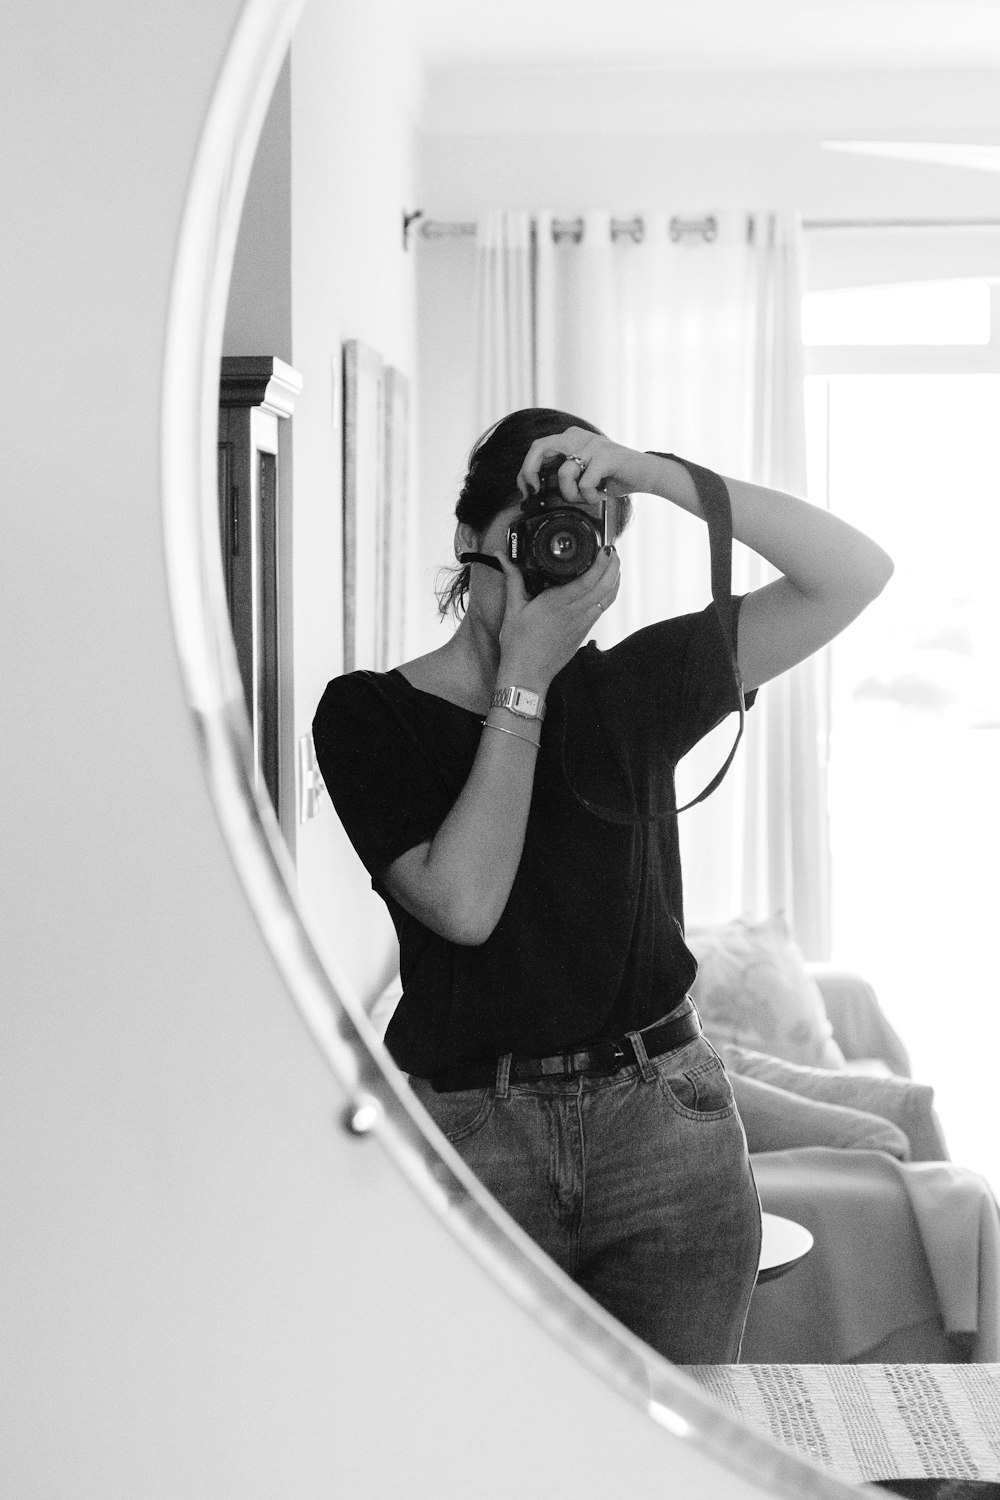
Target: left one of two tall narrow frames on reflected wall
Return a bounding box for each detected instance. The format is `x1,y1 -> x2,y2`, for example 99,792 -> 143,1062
343,339 -> 385,672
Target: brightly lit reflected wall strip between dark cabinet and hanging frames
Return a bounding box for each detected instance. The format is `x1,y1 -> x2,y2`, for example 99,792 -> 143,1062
284,0 -> 418,998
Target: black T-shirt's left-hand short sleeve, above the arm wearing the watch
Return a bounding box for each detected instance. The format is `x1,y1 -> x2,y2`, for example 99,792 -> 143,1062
312,672 -> 454,878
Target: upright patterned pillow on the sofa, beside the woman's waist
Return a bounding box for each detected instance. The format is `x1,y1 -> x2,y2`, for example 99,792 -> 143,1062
685,912 -> 844,1068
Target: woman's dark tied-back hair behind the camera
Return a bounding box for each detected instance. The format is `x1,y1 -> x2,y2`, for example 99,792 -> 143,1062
438,407 -> 630,617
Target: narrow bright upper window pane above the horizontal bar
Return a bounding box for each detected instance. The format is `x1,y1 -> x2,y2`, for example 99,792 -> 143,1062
802,279 -> 990,345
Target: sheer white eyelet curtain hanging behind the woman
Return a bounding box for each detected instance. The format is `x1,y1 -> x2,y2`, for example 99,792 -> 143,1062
477,210 -> 829,957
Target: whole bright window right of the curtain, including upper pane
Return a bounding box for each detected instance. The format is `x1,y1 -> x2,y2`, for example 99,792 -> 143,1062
804,255 -> 1000,1185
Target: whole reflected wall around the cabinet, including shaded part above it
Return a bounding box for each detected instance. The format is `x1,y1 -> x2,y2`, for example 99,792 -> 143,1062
223,0 -> 420,999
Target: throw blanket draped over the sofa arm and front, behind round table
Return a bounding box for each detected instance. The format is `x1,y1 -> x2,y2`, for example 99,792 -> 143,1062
744,1148 -> 1000,1365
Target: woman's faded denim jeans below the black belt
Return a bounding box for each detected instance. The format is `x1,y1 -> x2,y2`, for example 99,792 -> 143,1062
409,999 -> 760,1365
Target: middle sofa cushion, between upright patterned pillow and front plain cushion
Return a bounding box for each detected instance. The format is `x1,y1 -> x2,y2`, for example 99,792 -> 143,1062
720,1046 -> 949,1161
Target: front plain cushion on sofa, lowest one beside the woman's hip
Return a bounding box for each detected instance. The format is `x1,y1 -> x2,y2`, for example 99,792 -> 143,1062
729,1071 -> 910,1161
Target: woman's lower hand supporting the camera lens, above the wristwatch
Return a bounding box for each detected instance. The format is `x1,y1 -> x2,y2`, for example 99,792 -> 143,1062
495,548 -> 621,693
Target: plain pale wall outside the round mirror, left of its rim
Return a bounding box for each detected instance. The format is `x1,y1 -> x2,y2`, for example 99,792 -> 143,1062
0,0 -> 791,1500
